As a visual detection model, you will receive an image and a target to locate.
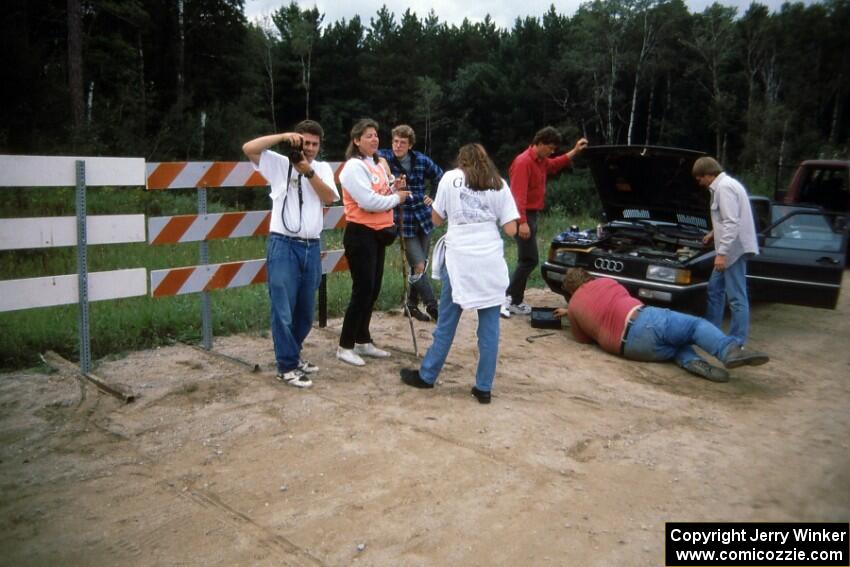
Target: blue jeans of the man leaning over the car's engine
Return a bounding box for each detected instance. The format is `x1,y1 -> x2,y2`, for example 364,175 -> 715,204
705,256 -> 750,345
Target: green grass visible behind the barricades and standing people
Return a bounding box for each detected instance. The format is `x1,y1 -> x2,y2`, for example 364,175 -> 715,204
0,183 -> 596,369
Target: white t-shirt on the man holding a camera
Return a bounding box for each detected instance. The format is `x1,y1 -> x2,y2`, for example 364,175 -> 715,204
251,150 -> 339,238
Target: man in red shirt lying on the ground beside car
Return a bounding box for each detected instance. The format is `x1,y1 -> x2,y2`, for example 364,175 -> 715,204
555,268 -> 770,382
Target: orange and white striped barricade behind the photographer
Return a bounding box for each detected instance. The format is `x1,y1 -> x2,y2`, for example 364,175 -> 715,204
147,162 -> 347,350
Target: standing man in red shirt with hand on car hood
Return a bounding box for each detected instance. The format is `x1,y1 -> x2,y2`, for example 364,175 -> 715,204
501,126 -> 587,318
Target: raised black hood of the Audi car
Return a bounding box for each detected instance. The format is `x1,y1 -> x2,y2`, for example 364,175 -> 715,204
581,146 -> 711,228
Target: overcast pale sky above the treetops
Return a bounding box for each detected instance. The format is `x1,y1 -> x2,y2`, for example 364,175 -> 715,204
245,0 -> 812,28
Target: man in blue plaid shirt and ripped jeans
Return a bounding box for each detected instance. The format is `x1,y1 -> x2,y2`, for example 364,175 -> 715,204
378,124 -> 443,321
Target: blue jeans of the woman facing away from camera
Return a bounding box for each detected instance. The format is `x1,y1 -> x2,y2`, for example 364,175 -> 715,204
419,267 -> 499,392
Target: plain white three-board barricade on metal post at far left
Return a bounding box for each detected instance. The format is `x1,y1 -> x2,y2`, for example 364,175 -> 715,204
0,156 -> 147,375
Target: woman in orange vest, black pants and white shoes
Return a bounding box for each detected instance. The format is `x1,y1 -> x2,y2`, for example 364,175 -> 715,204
336,118 -> 410,366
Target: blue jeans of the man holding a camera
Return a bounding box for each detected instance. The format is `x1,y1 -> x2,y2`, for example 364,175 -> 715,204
266,234 -> 322,373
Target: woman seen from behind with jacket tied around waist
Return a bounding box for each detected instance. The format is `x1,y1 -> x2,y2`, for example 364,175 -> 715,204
401,144 -> 519,404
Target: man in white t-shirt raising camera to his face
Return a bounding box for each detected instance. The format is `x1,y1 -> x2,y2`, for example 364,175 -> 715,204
242,120 -> 339,388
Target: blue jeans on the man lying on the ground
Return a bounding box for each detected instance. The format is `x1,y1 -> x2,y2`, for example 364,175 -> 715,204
623,307 -> 736,367
